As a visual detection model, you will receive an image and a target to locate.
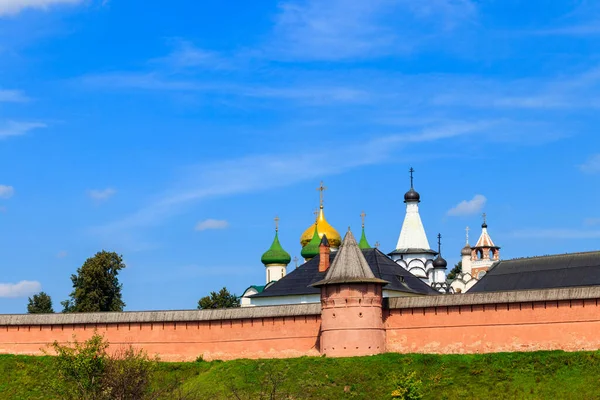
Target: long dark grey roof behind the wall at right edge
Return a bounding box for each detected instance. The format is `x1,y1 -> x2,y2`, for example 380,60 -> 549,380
469,251 -> 600,293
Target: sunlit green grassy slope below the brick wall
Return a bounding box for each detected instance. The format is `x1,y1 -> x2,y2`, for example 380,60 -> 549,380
0,352 -> 600,399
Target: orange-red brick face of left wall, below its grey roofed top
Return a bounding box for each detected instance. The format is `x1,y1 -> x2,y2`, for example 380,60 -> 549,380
0,315 -> 321,361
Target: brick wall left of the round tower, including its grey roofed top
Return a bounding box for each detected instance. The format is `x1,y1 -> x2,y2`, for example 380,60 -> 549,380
0,304 -> 321,361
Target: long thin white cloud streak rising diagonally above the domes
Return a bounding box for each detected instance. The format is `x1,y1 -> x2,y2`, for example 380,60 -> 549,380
94,121 -> 490,234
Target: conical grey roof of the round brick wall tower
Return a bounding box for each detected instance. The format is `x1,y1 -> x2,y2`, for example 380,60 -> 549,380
312,231 -> 389,286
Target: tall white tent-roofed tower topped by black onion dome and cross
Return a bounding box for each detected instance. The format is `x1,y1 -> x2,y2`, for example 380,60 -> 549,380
388,168 -> 437,285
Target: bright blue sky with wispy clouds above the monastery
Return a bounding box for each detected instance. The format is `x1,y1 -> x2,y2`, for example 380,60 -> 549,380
0,0 -> 600,313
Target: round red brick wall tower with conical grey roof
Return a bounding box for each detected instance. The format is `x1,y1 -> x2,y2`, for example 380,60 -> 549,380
312,230 -> 388,357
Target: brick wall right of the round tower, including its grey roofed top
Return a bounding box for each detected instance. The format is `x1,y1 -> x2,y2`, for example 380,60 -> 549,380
384,287 -> 600,354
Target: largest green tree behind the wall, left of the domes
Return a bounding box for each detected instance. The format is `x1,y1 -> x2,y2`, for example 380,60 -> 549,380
61,250 -> 125,312
